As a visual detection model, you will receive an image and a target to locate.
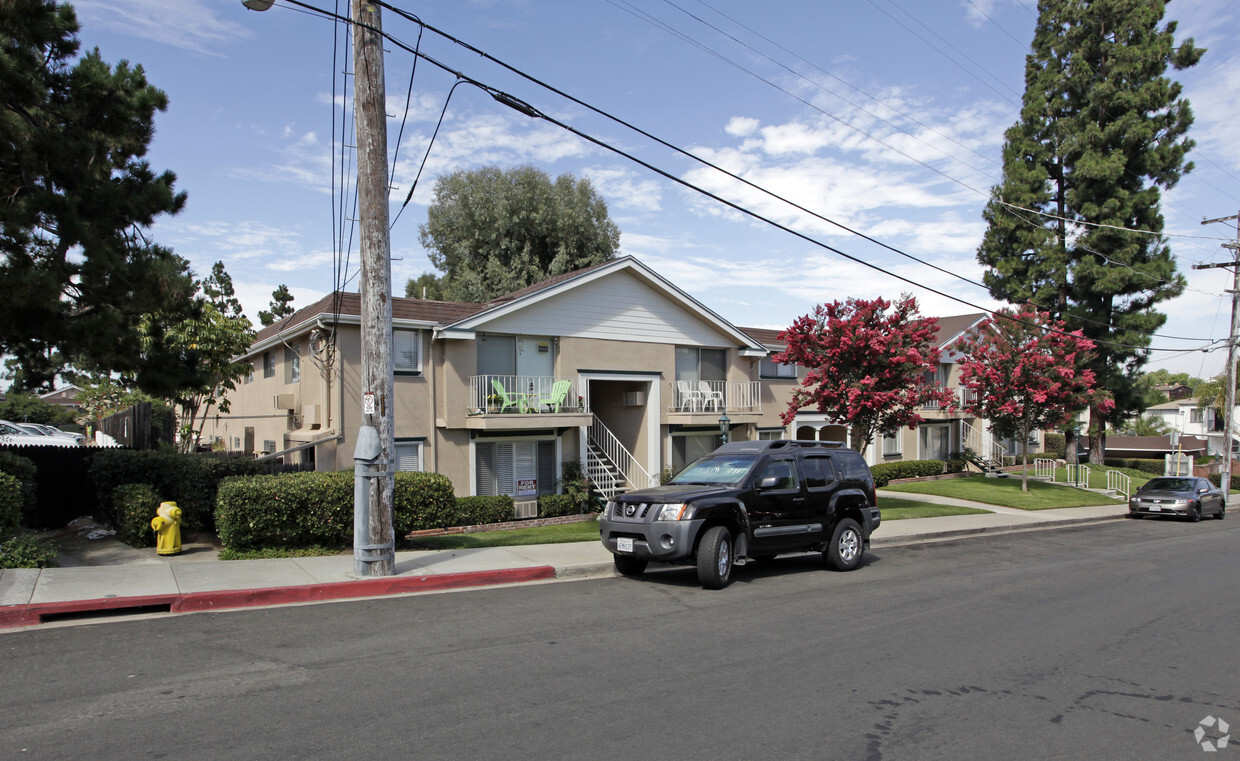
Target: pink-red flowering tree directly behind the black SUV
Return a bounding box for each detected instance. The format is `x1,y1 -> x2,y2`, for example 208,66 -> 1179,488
773,296 -> 955,451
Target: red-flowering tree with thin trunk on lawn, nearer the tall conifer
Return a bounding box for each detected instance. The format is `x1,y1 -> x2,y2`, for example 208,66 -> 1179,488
954,306 -> 1115,491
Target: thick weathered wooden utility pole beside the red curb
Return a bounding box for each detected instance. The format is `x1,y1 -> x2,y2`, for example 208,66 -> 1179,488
352,0 -> 396,576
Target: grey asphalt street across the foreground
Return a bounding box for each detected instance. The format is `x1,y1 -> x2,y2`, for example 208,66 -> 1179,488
0,517 -> 1240,761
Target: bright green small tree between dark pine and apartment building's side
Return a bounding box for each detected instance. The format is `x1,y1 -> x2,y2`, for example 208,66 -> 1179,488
134,262 -> 254,451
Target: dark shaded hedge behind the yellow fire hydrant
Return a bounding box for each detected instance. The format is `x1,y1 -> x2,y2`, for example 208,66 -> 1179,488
89,450 -> 264,530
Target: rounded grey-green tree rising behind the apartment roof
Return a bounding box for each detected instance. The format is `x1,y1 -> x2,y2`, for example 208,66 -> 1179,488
419,166 -> 620,302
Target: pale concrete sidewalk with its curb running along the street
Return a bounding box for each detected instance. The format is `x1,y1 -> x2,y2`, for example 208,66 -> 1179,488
0,492 -> 1127,628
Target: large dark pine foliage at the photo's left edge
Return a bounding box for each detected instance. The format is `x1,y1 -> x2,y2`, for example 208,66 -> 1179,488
0,0 -> 193,388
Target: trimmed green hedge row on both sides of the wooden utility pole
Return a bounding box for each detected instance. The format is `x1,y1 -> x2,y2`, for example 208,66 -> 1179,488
215,471 -> 463,550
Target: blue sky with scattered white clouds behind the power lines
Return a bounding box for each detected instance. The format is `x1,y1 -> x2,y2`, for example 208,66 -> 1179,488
74,0 -> 1240,377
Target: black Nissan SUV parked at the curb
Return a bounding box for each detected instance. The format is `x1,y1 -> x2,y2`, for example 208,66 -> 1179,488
599,440 -> 880,589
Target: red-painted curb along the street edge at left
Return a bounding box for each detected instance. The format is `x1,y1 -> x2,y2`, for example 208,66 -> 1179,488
0,565 -> 556,628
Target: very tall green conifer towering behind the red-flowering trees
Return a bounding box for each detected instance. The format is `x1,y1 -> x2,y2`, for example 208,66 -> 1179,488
977,0 -> 1204,462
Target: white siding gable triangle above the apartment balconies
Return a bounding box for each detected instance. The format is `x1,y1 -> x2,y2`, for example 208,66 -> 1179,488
476,271 -> 737,347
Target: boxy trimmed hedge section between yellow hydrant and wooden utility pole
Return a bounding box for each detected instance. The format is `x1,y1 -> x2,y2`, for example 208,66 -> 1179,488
215,471 -> 353,550
